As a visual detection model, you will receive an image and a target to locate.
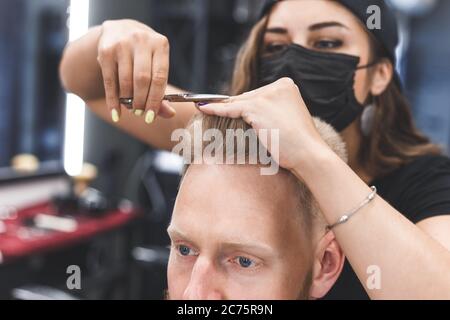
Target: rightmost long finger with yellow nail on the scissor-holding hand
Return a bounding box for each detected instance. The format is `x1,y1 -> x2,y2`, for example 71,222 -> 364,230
145,36 -> 169,124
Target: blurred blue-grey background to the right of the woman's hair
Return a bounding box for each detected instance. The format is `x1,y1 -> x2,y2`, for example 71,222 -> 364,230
405,0 -> 450,152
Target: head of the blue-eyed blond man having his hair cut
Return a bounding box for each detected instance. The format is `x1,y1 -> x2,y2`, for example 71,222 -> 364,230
168,116 -> 345,299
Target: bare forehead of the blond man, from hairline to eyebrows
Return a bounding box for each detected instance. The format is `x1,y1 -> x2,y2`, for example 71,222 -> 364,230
173,165 -> 298,245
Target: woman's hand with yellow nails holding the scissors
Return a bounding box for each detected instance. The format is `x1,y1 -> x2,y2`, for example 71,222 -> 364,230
97,20 -> 175,124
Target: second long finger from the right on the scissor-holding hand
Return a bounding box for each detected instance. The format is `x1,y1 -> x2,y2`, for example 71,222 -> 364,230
133,46 -> 152,116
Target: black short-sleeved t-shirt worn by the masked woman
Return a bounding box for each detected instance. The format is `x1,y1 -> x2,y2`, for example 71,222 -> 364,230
325,155 -> 450,300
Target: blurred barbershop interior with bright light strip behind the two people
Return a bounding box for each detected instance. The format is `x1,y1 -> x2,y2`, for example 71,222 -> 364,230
0,0 -> 450,299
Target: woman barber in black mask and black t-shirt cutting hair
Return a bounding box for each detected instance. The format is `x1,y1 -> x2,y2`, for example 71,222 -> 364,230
61,0 -> 450,299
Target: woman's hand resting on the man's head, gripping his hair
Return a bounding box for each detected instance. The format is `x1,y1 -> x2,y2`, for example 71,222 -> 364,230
199,78 -> 329,170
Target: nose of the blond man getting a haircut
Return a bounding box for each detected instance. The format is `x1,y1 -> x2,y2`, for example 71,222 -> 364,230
183,257 -> 224,300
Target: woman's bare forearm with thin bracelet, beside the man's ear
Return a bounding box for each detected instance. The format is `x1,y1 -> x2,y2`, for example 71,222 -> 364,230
294,146 -> 450,299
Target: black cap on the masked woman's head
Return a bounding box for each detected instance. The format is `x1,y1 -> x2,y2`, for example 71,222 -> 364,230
261,0 -> 399,73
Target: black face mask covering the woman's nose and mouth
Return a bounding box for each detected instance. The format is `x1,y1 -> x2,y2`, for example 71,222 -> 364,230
258,44 -> 369,131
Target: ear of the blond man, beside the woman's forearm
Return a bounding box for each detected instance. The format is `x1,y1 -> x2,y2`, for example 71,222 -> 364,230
309,231 -> 345,299
